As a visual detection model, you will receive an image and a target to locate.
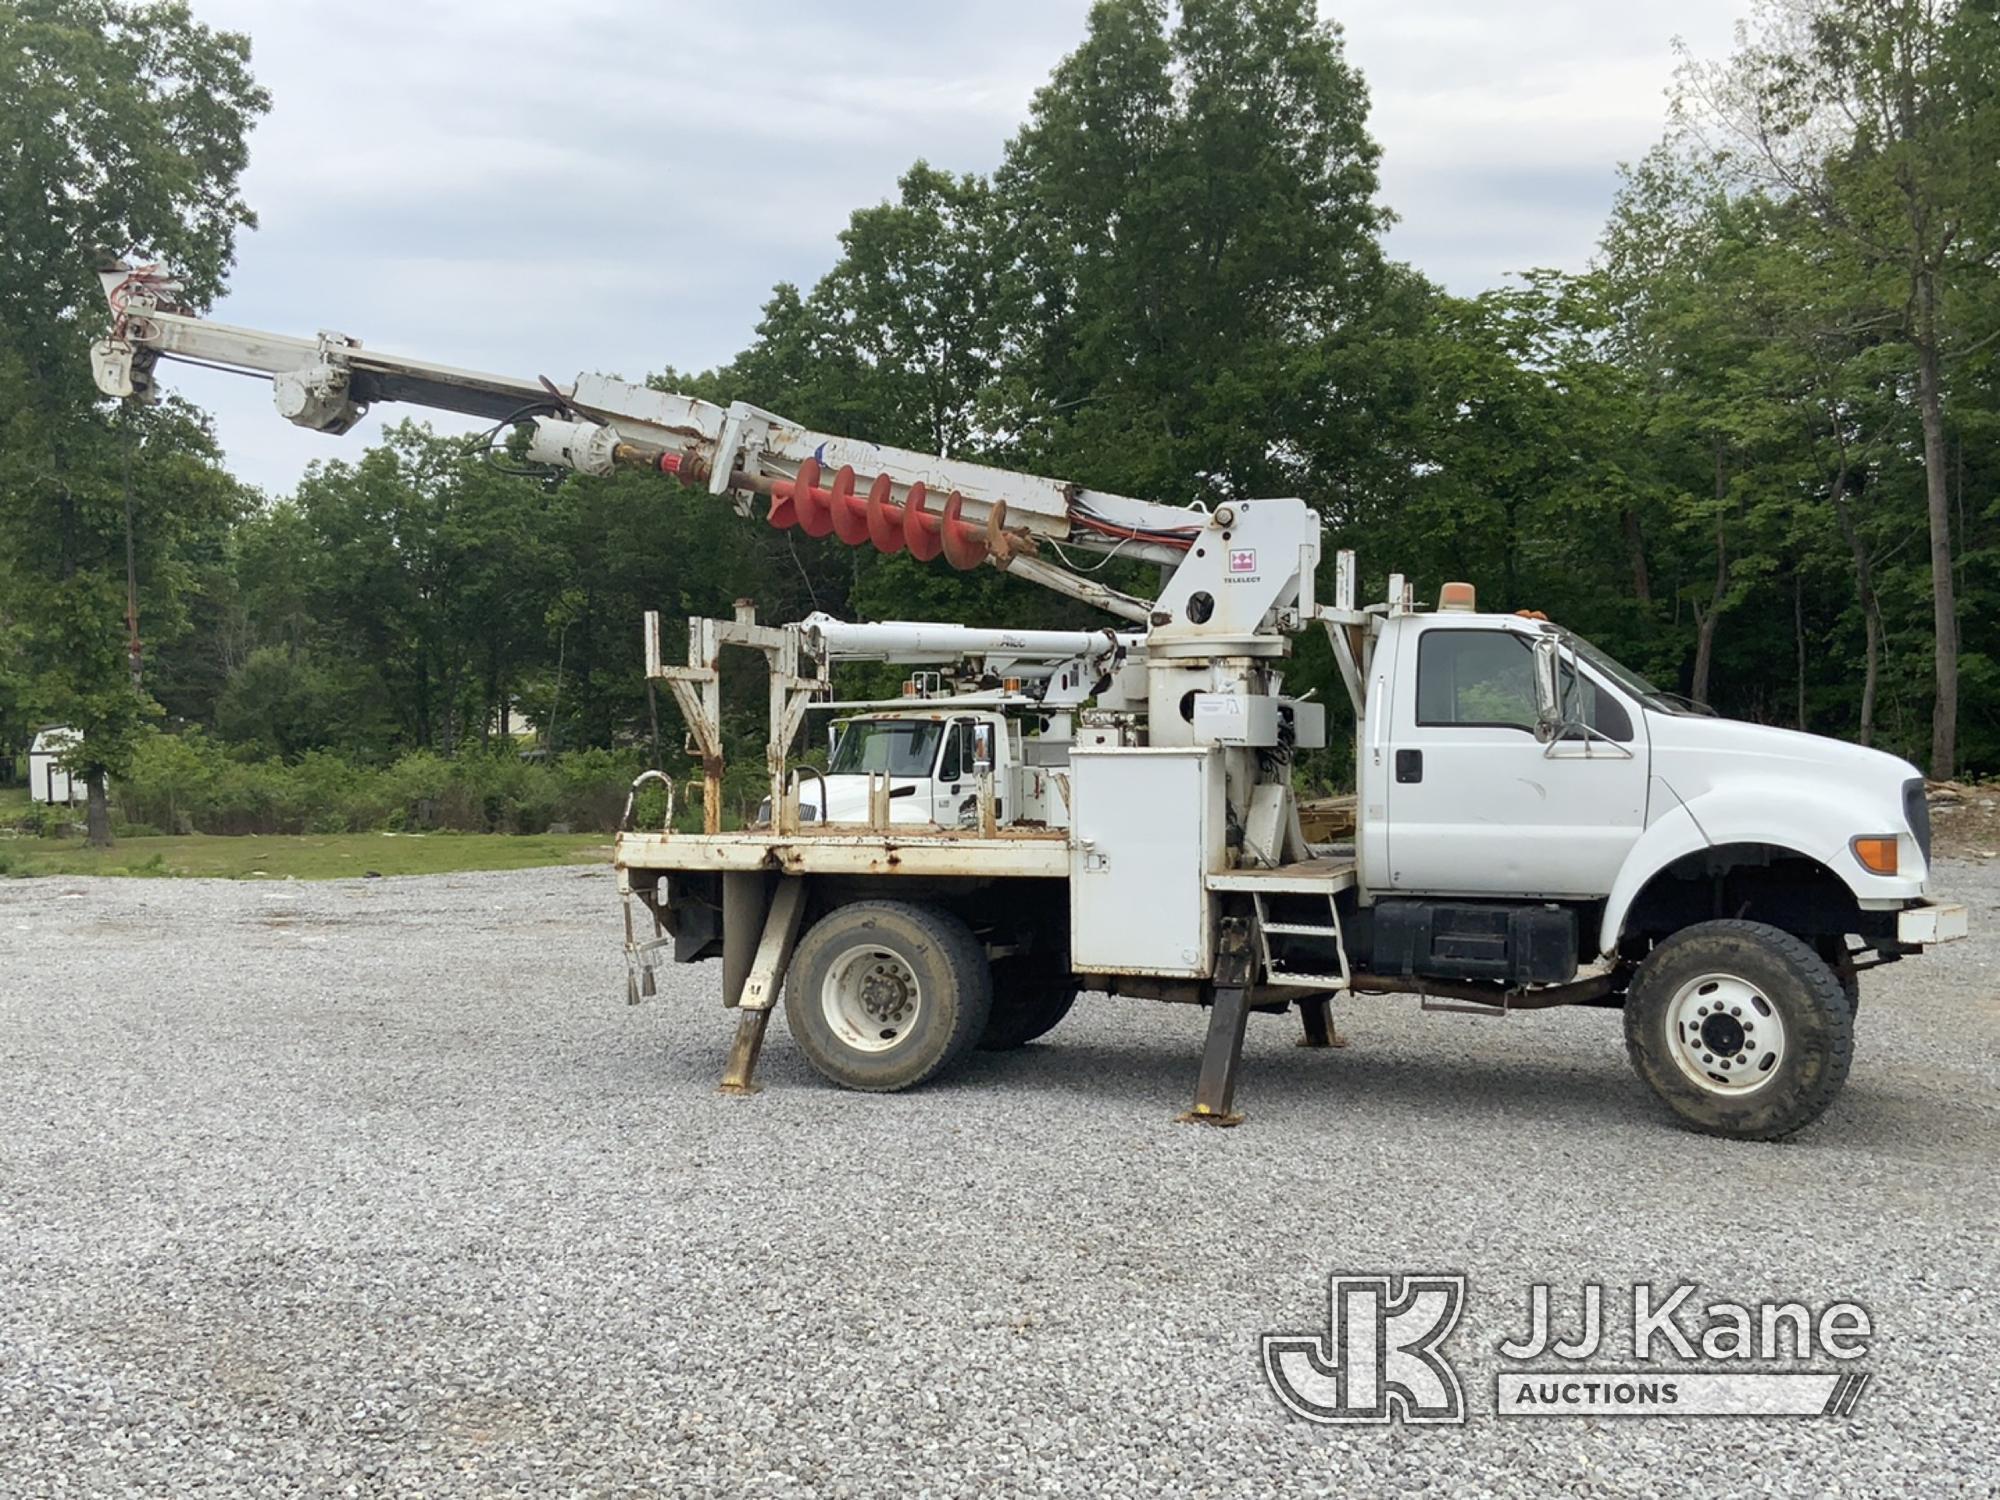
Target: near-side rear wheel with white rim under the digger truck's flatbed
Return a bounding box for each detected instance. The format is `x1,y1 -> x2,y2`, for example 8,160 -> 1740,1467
784,902 -> 992,1092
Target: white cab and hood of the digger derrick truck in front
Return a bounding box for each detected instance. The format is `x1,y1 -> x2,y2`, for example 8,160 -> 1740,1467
1358,610 -> 1932,962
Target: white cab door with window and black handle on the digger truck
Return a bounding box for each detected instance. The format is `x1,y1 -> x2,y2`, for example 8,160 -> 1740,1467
1376,620 -> 1648,898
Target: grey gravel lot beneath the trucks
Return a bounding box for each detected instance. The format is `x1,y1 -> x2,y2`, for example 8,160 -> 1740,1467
0,864 -> 2000,1496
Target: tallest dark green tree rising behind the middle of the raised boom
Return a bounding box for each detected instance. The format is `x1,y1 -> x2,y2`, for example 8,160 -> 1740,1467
996,0 -> 1390,500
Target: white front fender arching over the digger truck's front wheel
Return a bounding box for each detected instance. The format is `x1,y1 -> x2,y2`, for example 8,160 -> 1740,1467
1598,776 -> 1928,956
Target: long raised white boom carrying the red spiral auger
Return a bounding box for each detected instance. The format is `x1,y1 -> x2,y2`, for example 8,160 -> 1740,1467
92,262 -> 1264,622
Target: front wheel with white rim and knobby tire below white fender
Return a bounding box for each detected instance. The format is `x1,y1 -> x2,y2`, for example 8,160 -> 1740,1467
1624,922 -> 1854,1140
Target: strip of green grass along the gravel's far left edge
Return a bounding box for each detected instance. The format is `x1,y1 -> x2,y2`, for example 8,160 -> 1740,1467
0,834 -> 610,880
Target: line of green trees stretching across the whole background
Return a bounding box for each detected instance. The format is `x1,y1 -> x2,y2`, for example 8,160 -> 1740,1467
0,0 -> 2000,848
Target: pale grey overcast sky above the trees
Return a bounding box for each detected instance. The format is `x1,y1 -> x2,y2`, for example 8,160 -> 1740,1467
180,0 -> 1748,492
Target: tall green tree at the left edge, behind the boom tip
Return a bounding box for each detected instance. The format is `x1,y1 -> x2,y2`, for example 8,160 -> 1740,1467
0,0 -> 266,842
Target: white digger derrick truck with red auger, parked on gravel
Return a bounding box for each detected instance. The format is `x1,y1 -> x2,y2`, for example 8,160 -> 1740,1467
92,264 -> 1966,1138
